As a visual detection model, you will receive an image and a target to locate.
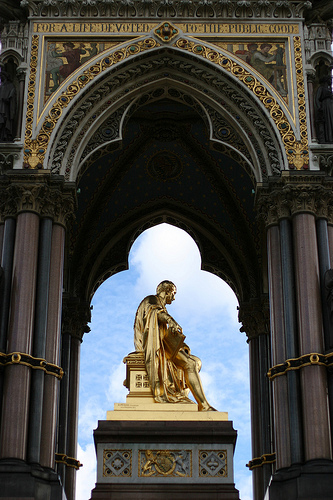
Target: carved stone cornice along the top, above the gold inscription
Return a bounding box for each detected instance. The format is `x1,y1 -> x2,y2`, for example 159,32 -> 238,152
21,0 -> 312,21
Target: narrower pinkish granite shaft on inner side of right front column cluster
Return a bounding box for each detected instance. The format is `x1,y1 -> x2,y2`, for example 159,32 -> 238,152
267,226 -> 291,469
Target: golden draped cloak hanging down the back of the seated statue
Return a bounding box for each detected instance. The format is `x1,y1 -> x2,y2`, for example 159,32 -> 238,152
134,295 -> 192,403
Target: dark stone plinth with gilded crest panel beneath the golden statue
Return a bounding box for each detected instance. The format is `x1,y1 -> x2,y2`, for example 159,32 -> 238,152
91,420 -> 239,500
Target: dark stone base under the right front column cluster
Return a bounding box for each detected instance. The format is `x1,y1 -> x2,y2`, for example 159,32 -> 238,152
265,460 -> 333,500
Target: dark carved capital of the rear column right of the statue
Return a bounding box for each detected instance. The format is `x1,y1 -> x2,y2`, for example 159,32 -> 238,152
238,296 -> 270,342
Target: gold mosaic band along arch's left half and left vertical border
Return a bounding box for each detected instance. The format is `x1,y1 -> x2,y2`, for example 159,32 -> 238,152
24,35 -> 160,168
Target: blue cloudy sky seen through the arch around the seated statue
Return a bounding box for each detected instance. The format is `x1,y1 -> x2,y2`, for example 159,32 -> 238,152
76,224 -> 252,500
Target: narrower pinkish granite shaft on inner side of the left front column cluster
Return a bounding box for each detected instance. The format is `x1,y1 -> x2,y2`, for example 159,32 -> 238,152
40,224 -> 65,469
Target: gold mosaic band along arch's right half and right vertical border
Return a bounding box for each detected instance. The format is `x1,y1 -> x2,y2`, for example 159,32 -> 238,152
175,36 -> 309,170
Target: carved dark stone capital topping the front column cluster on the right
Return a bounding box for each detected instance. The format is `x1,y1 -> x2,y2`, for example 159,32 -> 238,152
256,172 -> 333,227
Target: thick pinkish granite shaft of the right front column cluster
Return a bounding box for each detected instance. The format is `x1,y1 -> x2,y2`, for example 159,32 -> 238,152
293,213 -> 331,460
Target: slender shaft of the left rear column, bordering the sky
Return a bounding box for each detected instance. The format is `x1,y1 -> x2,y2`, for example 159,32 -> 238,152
65,337 -> 81,500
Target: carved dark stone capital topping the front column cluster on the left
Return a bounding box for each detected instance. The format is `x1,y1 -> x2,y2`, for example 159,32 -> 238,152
0,170 -> 76,226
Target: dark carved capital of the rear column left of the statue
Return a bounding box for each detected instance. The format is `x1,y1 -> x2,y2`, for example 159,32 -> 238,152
62,294 -> 91,342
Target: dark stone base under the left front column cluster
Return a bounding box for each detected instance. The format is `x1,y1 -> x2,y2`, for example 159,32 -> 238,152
0,459 -> 66,500
